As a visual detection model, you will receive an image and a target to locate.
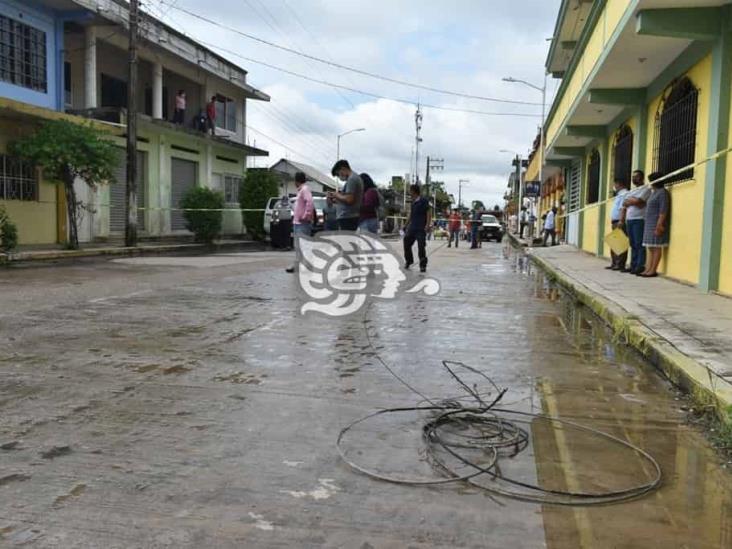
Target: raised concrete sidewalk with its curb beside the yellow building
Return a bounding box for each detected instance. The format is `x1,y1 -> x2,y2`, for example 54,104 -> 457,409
529,246 -> 732,424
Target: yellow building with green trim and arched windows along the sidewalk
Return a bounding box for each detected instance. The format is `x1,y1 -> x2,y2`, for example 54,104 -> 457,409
540,0 -> 732,294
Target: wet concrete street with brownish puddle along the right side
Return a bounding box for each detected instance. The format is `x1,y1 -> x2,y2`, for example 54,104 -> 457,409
0,243 -> 732,549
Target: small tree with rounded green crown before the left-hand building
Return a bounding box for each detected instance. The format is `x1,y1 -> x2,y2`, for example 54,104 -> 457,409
10,120 -> 121,249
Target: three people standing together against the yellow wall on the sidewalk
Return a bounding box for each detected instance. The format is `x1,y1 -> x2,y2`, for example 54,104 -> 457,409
606,170 -> 671,278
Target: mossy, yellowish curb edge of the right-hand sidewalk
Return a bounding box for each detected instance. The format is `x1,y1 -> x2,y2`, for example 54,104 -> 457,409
529,250 -> 732,426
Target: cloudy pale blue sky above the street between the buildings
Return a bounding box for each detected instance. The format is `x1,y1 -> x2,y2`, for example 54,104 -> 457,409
142,0 -> 560,207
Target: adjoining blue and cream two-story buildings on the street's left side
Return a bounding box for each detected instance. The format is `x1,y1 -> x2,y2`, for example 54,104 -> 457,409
0,0 -> 269,244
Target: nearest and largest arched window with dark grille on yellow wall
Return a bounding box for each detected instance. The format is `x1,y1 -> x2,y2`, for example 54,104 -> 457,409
653,77 -> 699,184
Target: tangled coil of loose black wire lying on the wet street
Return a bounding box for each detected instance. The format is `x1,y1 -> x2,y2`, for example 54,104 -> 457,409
336,306 -> 662,506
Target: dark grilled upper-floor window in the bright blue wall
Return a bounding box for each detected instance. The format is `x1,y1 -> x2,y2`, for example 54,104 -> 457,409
0,15 -> 48,93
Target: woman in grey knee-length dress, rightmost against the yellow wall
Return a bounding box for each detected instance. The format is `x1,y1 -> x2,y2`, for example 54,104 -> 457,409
638,173 -> 671,278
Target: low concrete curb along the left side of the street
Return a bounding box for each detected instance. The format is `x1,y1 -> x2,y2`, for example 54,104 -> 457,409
0,241 -> 261,266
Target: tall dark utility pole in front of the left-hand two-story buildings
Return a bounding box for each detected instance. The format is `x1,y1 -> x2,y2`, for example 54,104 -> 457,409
125,0 -> 139,246
